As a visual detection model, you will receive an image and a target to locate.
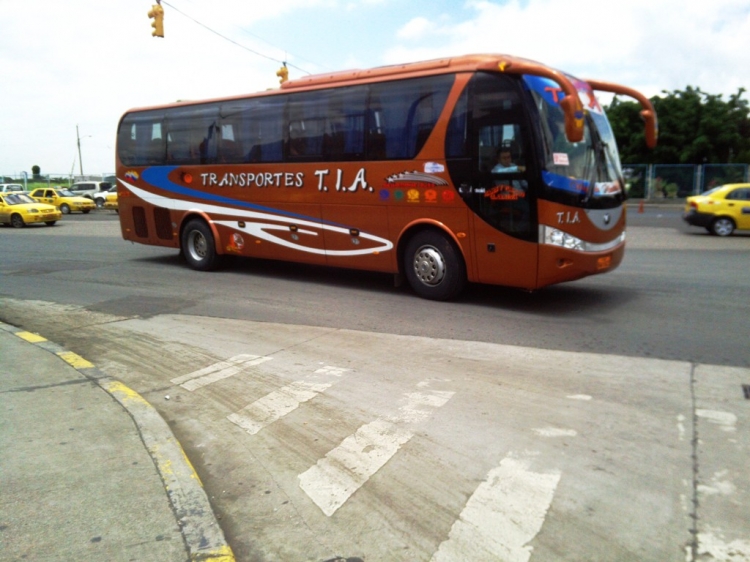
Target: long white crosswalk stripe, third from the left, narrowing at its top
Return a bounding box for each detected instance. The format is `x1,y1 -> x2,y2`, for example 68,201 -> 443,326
299,383 -> 454,517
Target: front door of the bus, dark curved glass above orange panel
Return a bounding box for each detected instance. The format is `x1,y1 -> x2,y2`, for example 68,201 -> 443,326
446,73 -> 538,288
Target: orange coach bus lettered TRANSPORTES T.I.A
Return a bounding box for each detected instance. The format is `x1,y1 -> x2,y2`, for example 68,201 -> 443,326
117,55 -> 657,300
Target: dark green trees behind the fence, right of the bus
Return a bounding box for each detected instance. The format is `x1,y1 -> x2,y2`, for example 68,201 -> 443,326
606,86 -> 750,164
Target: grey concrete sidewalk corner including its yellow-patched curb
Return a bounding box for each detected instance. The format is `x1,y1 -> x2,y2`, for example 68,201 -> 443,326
0,322 -> 234,562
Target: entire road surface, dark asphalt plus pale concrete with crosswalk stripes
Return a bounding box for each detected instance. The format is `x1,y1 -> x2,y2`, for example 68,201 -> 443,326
0,208 -> 750,562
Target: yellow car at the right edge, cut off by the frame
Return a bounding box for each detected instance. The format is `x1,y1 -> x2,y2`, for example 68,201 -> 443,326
682,183 -> 750,236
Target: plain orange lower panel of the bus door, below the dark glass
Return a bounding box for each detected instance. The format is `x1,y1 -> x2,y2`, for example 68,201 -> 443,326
472,213 -> 539,289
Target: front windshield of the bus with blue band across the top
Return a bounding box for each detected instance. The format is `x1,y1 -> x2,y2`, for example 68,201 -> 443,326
525,76 -> 625,209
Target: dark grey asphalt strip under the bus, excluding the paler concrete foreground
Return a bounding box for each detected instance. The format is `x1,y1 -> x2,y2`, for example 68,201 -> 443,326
0,203 -> 750,366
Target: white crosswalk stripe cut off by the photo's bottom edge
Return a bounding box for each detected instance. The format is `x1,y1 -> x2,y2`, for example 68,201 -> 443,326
430,453 -> 560,562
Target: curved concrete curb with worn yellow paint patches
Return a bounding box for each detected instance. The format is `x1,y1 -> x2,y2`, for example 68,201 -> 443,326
0,322 -> 235,562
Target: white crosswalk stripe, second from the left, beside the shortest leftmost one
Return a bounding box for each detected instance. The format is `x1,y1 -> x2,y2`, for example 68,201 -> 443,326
227,365 -> 349,435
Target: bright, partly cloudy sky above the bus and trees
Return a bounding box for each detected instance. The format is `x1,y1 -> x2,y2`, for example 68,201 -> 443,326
0,0 -> 750,178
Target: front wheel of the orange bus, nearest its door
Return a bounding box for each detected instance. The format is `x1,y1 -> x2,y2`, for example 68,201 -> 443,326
404,230 -> 466,301
